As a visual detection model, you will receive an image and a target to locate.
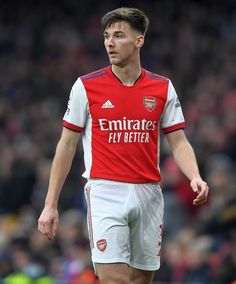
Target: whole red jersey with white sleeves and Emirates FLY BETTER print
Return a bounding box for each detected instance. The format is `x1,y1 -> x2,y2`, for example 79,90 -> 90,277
63,66 -> 185,183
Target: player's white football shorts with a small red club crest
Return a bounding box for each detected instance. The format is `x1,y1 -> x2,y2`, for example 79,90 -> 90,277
85,179 -> 164,271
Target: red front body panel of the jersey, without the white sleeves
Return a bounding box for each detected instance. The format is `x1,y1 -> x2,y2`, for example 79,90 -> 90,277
83,67 -> 169,183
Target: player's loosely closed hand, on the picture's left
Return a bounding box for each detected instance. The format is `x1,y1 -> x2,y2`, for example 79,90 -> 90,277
38,207 -> 59,240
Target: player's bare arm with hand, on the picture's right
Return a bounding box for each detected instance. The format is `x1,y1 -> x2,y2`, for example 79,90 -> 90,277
166,130 -> 209,205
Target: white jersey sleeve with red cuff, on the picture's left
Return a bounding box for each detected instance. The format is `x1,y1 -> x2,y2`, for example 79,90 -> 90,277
63,78 -> 89,132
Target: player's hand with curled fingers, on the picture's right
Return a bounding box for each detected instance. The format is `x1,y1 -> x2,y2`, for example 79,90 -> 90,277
190,178 -> 209,205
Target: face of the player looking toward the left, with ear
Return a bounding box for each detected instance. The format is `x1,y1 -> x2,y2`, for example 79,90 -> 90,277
104,22 -> 143,67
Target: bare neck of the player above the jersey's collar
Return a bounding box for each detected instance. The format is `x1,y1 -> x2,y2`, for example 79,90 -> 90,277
111,64 -> 142,86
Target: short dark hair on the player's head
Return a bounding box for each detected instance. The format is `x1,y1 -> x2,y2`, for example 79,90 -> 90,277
101,7 -> 149,35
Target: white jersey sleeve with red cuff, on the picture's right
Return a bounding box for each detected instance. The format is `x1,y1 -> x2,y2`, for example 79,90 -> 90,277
161,81 -> 185,133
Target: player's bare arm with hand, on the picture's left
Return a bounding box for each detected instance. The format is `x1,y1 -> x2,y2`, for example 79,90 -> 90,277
38,128 -> 80,240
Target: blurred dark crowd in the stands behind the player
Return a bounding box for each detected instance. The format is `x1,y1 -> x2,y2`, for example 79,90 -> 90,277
0,0 -> 236,284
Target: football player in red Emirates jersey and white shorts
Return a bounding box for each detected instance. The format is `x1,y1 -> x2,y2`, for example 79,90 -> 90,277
38,8 -> 208,284
